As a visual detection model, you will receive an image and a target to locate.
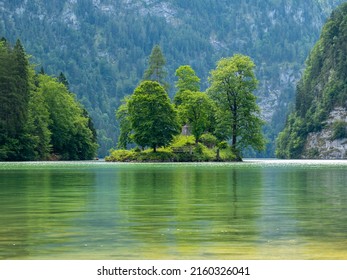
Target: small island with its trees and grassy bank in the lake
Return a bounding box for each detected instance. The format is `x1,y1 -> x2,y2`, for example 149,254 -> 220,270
105,45 -> 265,162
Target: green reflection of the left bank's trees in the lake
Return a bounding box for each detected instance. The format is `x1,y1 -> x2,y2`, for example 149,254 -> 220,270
0,168 -> 94,259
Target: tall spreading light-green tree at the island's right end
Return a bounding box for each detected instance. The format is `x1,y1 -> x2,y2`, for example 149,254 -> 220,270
208,54 -> 265,157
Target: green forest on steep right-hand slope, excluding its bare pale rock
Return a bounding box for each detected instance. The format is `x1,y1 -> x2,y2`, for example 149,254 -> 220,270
277,3 -> 347,158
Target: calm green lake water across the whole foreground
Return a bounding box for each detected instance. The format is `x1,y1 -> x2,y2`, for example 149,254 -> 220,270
0,160 -> 347,260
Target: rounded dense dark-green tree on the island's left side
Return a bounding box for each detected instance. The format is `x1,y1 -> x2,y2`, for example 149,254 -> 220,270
127,81 -> 180,152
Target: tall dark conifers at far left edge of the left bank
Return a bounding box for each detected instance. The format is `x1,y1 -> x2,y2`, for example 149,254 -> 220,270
0,39 -> 30,160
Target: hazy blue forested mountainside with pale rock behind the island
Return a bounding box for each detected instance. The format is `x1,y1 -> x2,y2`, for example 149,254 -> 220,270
0,0 -> 344,156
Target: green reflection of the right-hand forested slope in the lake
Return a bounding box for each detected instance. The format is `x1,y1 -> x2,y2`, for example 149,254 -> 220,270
287,166 -> 347,242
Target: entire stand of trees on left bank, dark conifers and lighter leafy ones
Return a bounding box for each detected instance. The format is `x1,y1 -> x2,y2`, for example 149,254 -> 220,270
0,39 -> 97,160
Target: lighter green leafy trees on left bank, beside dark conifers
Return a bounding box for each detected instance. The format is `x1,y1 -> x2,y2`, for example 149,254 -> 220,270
38,75 -> 96,160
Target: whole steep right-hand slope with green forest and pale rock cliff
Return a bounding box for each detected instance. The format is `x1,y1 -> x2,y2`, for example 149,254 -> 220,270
277,3 -> 347,159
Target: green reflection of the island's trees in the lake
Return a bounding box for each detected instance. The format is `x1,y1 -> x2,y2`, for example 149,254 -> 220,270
119,165 -> 262,254
